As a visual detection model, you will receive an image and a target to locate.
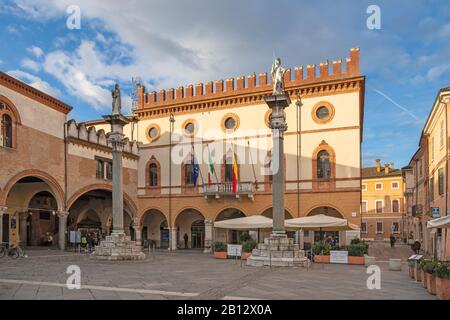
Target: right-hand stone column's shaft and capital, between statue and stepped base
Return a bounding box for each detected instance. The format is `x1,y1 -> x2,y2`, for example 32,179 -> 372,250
264,93 -> 291,235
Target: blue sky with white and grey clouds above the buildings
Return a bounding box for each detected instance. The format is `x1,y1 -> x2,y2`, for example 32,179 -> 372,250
0,0 -> 450,168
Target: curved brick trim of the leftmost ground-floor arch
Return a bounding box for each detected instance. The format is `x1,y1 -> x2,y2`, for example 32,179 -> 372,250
0,169 -> 65,211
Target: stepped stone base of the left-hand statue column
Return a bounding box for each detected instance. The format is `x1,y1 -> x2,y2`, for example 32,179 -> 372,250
93,231 -> 145,261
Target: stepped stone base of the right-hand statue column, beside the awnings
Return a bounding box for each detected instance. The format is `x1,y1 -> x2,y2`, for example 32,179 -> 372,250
247,232 -> 310,267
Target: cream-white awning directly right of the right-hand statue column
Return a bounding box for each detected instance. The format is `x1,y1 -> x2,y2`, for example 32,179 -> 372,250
285,214 -> 359,231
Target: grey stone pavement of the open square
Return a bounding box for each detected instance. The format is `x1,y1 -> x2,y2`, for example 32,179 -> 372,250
0,250 -> 435,299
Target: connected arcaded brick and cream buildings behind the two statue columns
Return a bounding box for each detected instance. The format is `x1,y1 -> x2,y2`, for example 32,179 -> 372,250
0,49 -> 365,249
